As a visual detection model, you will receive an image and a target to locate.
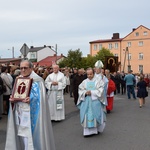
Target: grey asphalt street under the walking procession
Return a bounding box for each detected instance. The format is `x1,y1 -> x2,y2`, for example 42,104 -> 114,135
0,92 -> 150,150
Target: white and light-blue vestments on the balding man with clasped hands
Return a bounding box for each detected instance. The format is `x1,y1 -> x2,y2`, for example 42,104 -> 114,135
77,77 -> 106,136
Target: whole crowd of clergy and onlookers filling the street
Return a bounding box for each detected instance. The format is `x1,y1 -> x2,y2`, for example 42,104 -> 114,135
0,60 -> 150,150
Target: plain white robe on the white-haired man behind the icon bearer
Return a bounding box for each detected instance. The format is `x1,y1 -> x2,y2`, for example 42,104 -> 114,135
45,71 -> 66,121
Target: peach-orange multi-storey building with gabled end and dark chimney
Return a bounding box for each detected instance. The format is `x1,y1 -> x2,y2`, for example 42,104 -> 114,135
89,25 -> 150,73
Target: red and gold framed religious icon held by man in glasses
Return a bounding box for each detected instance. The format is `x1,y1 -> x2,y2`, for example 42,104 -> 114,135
12,77 -> 33,101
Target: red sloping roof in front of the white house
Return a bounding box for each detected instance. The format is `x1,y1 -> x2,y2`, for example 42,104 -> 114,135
34,55 -> 65,66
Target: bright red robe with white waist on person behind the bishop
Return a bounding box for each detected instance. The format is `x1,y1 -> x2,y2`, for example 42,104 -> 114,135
106,79 -> 116,111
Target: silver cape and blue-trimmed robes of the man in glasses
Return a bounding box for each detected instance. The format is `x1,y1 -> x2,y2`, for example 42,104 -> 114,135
5,71 -> 55,150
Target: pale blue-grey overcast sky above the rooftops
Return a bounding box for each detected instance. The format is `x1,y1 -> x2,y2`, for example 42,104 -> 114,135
0,0 -> 150,58
